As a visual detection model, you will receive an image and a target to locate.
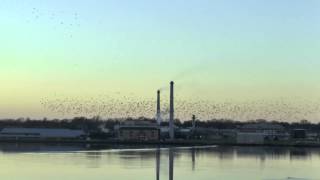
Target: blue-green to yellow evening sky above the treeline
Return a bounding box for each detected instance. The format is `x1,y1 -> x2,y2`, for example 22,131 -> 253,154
0,0 -> 320,122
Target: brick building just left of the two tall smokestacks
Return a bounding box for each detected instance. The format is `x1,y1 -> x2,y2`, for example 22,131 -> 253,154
116,121 -> 160,141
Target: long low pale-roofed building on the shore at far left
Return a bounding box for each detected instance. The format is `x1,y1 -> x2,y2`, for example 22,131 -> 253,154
0,128 -> 86,139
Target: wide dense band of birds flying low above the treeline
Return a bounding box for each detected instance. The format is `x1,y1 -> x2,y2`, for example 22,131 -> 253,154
41,90 -> 320,121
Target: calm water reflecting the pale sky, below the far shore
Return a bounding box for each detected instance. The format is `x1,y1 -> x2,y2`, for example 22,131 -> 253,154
0,144 -> 320,180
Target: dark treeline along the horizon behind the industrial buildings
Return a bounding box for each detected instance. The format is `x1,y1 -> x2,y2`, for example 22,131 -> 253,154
0,116 -> 320,132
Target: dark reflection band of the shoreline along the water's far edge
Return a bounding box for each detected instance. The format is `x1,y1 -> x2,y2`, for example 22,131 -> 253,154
0,143 -> 320,161
